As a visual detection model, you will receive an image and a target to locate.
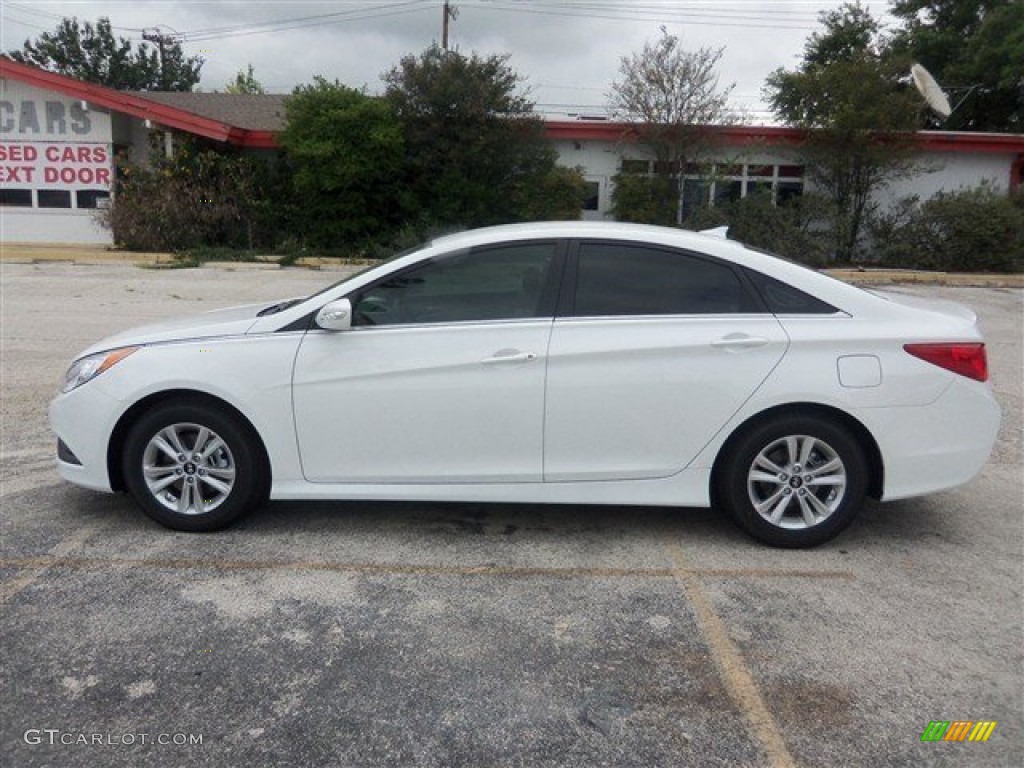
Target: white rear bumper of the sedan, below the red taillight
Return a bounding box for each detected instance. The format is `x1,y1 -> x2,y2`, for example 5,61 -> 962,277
857,378 -> 1001,501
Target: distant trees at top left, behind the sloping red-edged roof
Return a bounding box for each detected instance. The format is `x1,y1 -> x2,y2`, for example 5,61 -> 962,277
7,16 -> 203,91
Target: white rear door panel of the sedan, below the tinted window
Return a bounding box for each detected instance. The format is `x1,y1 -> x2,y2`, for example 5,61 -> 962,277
544,315 -> 787,481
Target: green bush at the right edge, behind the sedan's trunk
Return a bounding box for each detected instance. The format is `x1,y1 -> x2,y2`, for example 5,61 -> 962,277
869,184 -> 1024,272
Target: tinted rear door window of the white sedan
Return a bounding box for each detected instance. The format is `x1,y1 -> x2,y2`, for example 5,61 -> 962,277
572,243 -> 763,317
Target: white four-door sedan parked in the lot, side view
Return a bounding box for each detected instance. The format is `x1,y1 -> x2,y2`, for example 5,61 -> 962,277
50,222 -> 999,547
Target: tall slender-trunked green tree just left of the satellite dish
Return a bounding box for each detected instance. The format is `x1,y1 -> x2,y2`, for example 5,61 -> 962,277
765,3 -> 923,260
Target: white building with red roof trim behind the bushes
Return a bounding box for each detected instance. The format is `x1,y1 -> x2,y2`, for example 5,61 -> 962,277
6,56 -> 1024,244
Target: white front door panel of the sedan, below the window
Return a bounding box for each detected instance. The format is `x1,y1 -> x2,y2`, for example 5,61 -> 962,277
293,318 -> 552,483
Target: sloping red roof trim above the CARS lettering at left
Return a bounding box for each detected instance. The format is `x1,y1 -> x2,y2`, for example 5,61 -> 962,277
0,56 -> 276,146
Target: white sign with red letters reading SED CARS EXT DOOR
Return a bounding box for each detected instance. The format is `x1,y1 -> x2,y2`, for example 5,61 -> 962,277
0,141 -> 113,189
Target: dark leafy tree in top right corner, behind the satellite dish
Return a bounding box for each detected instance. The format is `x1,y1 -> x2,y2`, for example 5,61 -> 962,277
890,0 -> 1024,133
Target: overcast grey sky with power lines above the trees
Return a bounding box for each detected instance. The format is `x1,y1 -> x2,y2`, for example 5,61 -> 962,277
0,0 -> 892,122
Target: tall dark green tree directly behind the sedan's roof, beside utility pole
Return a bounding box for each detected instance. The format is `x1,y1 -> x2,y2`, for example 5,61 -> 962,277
384,45 -> 584,226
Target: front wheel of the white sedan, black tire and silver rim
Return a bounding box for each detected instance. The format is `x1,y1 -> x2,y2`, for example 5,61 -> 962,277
122,402 -> 269,531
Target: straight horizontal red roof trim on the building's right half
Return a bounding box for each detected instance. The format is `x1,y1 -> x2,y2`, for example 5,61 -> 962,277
545,121 -> 1024,153
